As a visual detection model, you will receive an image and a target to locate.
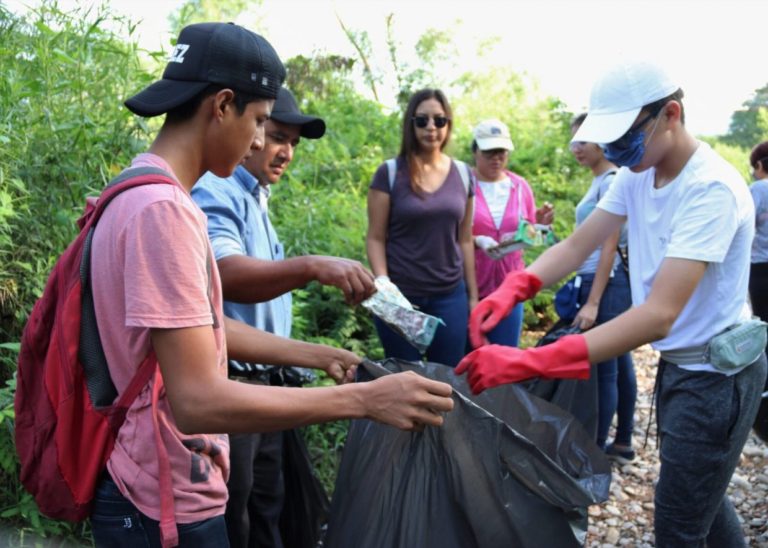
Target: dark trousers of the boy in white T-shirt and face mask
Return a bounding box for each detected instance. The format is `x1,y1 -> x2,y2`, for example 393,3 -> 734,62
654,354 -> 766,548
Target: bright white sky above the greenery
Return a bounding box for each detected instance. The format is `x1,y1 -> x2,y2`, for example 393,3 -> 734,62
6,0 -> 768,135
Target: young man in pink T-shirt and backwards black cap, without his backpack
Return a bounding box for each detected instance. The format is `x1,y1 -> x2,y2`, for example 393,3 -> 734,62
91,23 -> 453,547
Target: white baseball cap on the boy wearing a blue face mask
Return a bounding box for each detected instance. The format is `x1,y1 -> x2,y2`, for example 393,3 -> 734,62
572,61 -> 680,144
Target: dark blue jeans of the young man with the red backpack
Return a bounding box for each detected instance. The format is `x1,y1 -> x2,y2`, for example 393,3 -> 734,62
91,474 -> 229,548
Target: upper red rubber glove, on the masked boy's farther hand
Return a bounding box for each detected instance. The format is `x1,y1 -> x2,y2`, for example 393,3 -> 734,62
469,270 -> 542,348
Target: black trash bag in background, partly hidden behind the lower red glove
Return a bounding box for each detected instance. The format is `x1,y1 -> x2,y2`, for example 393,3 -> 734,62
518,320 -> 598,440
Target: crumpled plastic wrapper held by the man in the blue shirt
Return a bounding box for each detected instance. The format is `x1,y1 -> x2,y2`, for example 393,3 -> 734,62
362,277 -> 445,354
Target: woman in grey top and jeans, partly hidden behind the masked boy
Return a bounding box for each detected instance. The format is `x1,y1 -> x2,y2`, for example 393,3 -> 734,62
570,113 -> 637,464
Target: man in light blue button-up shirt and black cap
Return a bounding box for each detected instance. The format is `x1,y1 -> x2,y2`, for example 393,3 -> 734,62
192,89 -> 375,547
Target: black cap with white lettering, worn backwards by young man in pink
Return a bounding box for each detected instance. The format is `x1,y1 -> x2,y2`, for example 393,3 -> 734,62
125,23 -> 285,117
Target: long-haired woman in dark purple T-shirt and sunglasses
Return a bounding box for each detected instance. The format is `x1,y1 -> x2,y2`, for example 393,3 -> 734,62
366,89 -> 477,367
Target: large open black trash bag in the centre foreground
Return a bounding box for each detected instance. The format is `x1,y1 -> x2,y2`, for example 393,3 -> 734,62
324,359 -> 611,548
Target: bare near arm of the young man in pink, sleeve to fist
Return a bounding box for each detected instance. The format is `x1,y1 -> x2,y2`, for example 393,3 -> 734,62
151,326 -> 453,434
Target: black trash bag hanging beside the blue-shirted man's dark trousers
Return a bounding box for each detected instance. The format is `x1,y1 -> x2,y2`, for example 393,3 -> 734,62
279,429 -> 331,548
